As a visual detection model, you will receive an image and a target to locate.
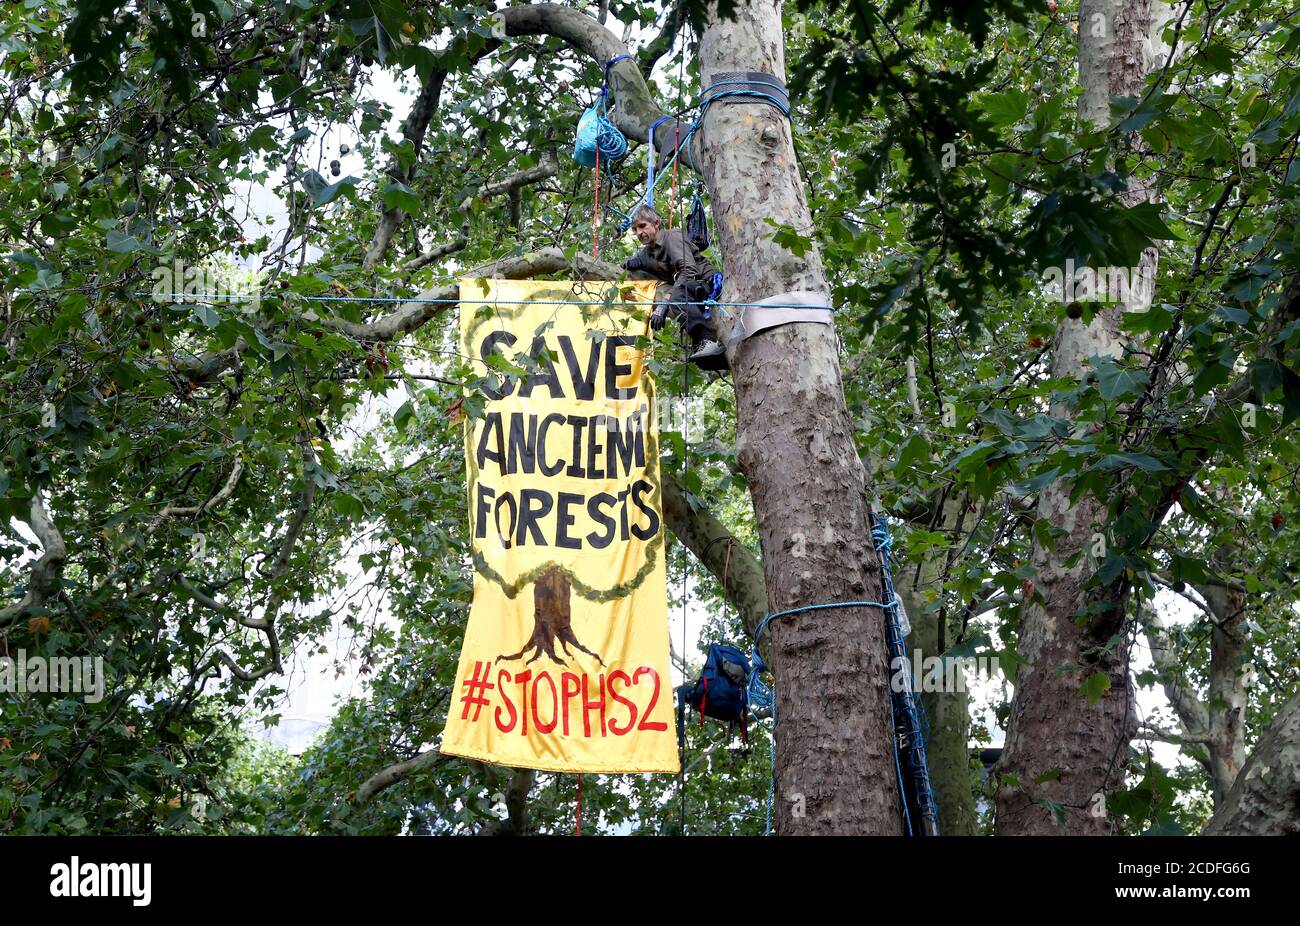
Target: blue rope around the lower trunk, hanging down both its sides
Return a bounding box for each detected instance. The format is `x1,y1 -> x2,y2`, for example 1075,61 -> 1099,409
746,515 -> 939,836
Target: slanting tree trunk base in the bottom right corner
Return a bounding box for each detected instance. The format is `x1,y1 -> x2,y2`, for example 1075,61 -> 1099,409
1204,695 -> 1300,836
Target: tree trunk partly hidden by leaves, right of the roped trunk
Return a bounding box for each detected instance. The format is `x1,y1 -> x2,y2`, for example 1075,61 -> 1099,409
997,0 -> 1167,835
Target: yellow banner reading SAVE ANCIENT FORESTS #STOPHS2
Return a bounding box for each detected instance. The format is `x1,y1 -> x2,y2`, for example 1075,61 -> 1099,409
441,280 -> 679,771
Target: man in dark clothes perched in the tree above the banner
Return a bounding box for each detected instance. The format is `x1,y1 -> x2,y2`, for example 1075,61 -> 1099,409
623,205 -> 725,369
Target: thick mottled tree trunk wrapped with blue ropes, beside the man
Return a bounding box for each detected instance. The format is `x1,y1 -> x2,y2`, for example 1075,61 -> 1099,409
697,0 -> 900,835
